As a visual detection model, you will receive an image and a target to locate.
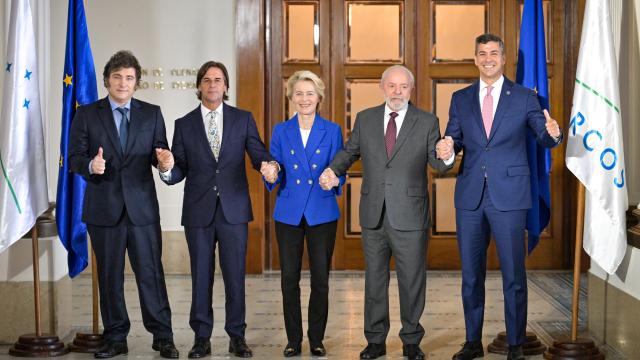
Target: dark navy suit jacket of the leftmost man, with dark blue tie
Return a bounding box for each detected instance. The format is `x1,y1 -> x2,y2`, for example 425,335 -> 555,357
69,97 -> 169,226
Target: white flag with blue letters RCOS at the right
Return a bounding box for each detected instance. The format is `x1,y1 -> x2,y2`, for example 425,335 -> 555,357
566,0 -> 628,274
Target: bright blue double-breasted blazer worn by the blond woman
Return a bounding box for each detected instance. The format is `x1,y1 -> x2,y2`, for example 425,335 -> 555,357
265,114 -> 345,226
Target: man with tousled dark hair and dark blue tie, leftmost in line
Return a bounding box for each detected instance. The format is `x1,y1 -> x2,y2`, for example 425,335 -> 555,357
69,51 -> 178,358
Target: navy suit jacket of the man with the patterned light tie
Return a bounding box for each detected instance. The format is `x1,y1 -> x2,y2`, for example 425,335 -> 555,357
165,104 -> 272,227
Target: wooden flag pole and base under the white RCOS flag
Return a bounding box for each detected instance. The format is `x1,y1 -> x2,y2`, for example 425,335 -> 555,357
543,181 -> 605,360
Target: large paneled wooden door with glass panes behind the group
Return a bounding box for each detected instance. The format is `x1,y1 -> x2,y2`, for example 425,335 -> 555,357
262,0 -> 565,270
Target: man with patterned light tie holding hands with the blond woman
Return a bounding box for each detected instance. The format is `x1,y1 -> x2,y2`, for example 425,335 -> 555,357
159,61 -> 279,358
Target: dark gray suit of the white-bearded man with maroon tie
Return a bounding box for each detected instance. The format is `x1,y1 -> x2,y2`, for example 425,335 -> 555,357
329,104 -> 453,345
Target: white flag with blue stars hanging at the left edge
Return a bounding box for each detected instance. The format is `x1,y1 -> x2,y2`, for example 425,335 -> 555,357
0,0 -> 49,252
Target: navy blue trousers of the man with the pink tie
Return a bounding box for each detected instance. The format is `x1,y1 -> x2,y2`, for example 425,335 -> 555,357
456,183 -> 527,345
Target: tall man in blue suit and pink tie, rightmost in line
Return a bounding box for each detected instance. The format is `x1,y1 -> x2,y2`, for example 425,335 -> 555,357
437,34 -> 562,360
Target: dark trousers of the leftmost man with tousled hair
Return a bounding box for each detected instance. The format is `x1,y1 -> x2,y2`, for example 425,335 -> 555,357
87,210 -> 173,341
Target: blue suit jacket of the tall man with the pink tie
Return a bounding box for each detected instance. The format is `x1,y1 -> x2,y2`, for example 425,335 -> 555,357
445,78 -> 556,211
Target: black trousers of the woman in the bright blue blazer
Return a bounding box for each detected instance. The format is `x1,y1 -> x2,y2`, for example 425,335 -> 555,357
276,217 -> 338,346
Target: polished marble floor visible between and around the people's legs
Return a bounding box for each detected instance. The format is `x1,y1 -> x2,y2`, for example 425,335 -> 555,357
0,271 -> 624,360
